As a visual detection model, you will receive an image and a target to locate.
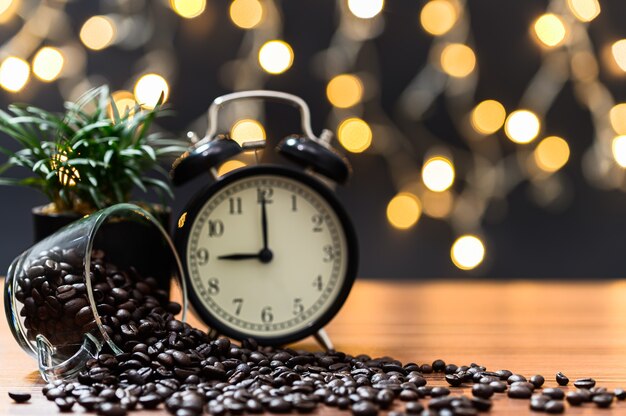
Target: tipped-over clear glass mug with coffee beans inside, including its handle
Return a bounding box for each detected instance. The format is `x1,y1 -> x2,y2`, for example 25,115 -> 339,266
5,204 -> 187,381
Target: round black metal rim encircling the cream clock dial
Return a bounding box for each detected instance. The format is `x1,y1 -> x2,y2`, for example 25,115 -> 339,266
174,165 -> 359,346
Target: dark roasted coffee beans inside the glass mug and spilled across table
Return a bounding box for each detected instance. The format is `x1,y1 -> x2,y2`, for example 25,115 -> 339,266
12,250 -> 626,416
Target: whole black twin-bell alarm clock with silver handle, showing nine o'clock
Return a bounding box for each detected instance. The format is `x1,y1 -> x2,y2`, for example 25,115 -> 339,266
171,90 -> 358,349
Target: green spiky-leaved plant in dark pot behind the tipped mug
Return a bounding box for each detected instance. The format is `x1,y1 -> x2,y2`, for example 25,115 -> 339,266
0,86 -> 188,240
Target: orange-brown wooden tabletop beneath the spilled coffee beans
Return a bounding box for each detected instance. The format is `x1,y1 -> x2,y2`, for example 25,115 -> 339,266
0,280 -> 626,415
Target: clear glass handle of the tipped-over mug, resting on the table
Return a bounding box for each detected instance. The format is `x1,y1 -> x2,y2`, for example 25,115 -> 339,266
37,334 -> 102,383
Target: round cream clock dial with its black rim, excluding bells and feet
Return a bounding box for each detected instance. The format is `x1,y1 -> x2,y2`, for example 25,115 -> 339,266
181,167 -> 356,343
